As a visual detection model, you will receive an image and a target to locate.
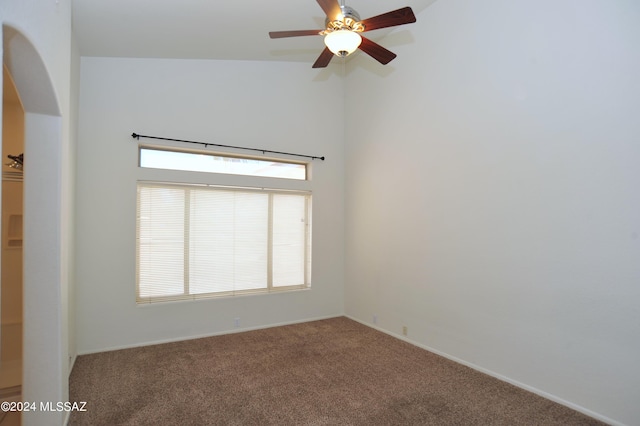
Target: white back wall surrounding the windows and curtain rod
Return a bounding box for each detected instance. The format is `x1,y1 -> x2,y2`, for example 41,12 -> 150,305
76,57 -> 344,353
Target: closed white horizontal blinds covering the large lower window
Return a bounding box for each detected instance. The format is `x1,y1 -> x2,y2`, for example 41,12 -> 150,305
136,183 -> 311,303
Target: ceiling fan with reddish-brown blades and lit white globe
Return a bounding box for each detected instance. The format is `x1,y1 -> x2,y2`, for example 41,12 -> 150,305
269,0 -> 416,68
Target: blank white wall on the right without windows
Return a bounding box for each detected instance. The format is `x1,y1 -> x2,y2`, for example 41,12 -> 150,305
345,0 -> 640,424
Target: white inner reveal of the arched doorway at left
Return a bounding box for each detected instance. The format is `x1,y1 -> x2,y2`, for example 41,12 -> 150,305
2,25 -> 68,425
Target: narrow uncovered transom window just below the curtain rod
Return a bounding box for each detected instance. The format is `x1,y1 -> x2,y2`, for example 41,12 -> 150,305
140,147 -> 307,180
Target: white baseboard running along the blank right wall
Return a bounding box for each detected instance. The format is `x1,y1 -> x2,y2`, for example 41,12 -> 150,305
344,314 -> 625,426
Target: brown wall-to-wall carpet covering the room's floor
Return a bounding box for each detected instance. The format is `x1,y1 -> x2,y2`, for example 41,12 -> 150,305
69,317 -> 602,426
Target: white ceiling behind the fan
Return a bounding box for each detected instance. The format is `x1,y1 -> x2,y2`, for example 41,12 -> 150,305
73,0 -> 435,65
